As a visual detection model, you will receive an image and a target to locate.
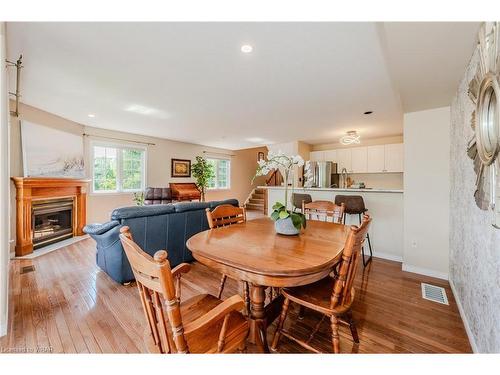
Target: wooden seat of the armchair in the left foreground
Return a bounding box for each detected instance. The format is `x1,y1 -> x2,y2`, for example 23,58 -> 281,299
148,294 -> 248,353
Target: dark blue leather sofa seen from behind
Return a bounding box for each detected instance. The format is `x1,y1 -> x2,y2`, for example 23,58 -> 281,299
83,199 -> 238,284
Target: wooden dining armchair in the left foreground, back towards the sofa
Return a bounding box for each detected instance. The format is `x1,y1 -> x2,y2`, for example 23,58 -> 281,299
120,226 -> 249,353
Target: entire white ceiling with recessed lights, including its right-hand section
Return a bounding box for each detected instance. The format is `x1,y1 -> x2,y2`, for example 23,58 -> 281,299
7,22 -> 478,149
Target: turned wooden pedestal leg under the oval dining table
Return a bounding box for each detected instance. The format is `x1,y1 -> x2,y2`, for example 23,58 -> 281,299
249,284 -> 269,353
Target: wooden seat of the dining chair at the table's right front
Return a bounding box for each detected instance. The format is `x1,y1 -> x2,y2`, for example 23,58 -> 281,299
283,276 -> 354,315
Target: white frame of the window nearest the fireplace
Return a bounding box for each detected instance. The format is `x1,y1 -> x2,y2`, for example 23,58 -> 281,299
89,141 -> 148,195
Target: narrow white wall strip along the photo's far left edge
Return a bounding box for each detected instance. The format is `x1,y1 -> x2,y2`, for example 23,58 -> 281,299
0,22 -> 9,336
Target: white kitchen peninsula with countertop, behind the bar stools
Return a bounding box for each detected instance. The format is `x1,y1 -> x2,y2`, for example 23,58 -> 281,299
260,186 -> 403,262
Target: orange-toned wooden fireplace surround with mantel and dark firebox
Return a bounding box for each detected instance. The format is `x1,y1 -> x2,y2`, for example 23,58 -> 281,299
12,177 -> 89,256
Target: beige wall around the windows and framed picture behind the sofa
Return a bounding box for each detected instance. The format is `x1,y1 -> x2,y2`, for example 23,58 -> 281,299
10,101 -> 267,251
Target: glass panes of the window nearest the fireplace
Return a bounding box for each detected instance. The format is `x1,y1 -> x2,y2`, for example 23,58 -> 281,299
91,143 -> 146,193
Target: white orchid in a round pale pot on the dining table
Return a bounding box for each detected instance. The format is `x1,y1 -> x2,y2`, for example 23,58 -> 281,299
254,151 -> 306,235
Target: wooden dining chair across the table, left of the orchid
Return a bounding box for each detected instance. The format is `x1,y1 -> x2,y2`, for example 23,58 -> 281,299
206,204 -> 250,313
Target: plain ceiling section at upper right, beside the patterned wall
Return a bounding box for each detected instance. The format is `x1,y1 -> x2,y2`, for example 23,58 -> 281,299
383,22 -> 479,112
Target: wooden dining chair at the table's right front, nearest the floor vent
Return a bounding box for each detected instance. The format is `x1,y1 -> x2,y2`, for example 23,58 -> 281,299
271,215 -> 372,353
